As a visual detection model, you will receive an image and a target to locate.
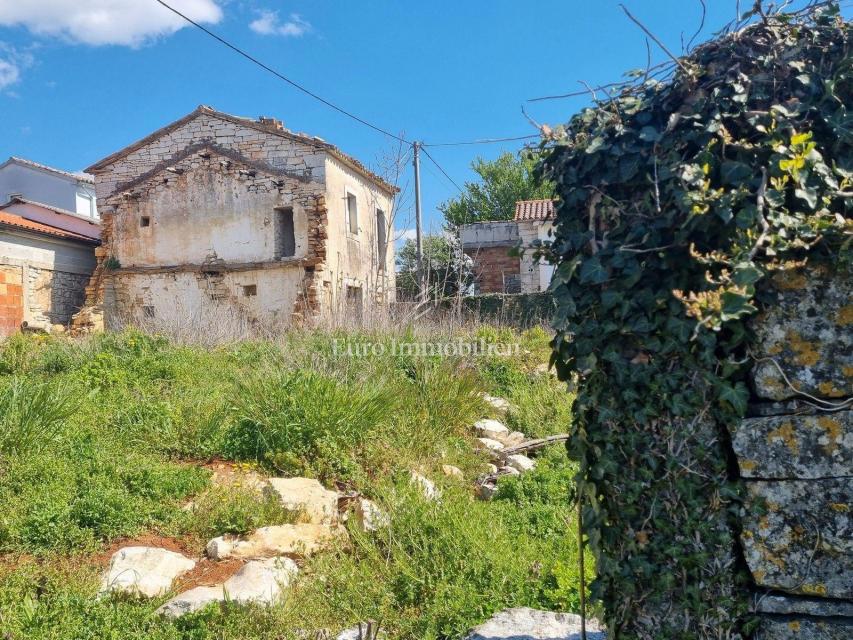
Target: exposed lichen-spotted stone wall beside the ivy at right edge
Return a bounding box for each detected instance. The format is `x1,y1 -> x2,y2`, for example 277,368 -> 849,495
731,265 -> 853,640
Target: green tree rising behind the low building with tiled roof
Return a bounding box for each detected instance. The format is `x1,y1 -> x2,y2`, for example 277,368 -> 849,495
439,152 -> 554,228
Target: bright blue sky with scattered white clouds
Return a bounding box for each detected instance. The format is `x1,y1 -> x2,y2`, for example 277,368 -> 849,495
0,0 -> 832,245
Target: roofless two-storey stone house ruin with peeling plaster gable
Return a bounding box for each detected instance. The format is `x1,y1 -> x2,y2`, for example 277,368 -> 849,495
78,106 -> 396,327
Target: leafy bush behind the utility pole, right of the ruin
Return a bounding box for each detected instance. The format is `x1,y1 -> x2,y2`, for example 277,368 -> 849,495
397,235 -> 473,300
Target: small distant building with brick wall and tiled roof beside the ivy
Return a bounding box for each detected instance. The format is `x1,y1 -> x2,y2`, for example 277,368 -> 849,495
462,200 -> 554,293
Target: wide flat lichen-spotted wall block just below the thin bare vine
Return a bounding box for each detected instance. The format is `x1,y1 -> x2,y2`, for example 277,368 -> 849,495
732,411 -> 853,479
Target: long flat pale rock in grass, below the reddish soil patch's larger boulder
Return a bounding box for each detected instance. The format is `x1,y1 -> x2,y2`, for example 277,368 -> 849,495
207,523 -> 346,560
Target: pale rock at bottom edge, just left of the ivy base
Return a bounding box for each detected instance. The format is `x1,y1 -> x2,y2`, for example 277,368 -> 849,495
465,607 -> 606,640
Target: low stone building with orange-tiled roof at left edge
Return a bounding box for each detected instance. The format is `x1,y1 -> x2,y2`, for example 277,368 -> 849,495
0,198 -> 100,337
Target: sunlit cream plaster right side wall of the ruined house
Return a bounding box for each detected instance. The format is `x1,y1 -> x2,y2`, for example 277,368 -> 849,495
322,156 -> 395,305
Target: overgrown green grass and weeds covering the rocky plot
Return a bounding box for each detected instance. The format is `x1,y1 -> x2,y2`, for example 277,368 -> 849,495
0,327 -> 592,640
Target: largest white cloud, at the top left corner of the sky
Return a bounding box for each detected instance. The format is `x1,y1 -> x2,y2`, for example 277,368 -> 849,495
0,0 -> 222,47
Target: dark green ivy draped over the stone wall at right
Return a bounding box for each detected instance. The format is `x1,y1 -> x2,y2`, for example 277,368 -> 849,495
541,3 -> 853,639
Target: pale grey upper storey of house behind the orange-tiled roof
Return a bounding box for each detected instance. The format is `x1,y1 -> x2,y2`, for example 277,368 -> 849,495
0,156 -> 98,220
